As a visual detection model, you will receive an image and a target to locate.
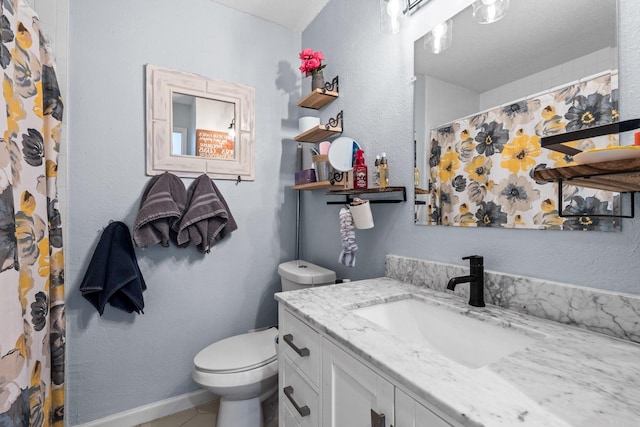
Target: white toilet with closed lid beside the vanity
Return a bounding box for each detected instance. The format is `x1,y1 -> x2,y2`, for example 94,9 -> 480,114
192,260 -> 336,427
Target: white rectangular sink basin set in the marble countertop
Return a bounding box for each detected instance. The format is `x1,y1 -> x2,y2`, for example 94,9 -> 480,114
352,298 -> 544,368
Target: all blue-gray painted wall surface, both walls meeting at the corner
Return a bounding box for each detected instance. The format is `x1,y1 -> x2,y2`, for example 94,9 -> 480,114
58,0 -> 640,425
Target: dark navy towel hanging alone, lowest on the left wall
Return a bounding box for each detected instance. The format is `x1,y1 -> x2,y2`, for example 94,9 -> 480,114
80,221 -> 147,316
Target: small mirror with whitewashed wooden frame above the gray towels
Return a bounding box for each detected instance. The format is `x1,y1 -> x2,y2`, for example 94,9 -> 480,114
146,64 -> 255,180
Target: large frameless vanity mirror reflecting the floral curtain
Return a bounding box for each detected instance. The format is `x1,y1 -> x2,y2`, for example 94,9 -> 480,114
414,0 -> 621,231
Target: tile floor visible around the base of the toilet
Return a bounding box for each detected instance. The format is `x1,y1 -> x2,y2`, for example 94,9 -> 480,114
136,394 -> 278,427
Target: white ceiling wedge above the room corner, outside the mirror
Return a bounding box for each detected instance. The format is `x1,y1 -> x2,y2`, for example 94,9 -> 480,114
211,0 -> 329,32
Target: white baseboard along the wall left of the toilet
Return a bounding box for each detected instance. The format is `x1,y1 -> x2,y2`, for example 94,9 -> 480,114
76,390 -> 216,427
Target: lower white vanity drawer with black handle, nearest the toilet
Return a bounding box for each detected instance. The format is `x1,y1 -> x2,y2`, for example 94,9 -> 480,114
279,356 -> 320,427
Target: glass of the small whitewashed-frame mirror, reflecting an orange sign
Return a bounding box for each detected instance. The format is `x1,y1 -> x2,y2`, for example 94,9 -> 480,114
171,92 -> 236,160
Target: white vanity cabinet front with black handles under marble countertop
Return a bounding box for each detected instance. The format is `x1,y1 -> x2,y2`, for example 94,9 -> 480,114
278,304 -> 451,427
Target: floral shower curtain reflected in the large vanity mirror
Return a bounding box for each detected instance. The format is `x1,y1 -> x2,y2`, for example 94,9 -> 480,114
425,72 -> 621,231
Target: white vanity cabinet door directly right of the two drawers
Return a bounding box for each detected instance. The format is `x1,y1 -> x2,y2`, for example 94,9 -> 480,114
322,339 -> 394,427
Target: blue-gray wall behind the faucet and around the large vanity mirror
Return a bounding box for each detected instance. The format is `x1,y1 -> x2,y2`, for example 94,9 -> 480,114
302,0 -> 640,294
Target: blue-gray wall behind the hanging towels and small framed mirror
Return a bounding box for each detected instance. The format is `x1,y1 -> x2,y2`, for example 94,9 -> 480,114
65,0 -> 300,425
